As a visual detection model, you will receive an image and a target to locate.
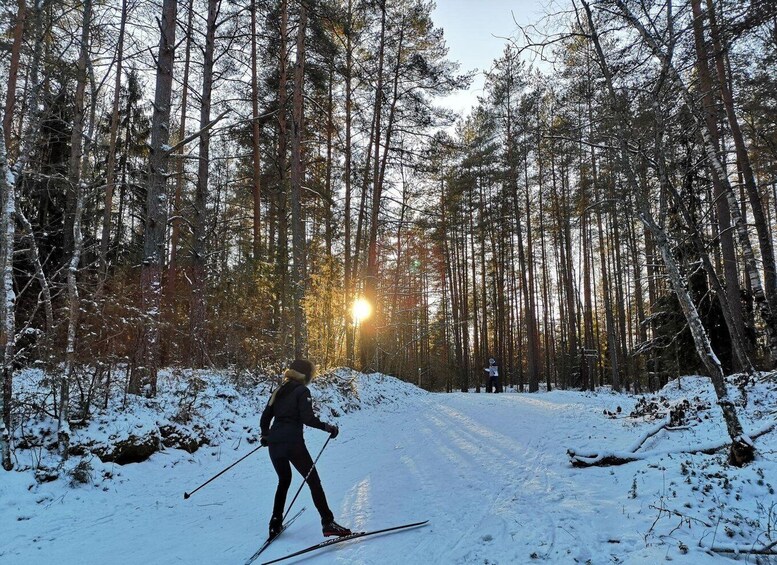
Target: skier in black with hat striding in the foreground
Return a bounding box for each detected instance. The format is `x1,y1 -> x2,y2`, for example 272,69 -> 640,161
259,359 -> 351,538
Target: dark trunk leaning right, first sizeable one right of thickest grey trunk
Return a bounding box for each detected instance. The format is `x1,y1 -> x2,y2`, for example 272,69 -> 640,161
189,0 -> 221,367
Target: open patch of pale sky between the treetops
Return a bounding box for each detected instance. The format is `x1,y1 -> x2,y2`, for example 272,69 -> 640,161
433,0 -> 548,113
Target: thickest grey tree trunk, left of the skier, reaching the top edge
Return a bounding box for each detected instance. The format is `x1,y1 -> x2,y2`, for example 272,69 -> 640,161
128,0 -> 178,395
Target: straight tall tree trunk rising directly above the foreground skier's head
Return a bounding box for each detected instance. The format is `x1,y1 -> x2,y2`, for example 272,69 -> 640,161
291,2 -> 308,359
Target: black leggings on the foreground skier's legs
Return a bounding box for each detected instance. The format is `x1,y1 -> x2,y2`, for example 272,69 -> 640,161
269,442 -> 334,523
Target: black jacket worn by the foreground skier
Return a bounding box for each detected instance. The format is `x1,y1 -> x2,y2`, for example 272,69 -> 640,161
259,371 -> 326,443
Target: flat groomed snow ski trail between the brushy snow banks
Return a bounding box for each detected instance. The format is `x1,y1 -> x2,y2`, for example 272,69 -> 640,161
0,374 -> 772,565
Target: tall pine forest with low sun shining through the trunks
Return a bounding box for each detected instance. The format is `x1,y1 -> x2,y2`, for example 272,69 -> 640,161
0,0 -> 777,469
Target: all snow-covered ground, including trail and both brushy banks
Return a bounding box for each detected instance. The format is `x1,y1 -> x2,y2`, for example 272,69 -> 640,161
0,370 -> 777,565
